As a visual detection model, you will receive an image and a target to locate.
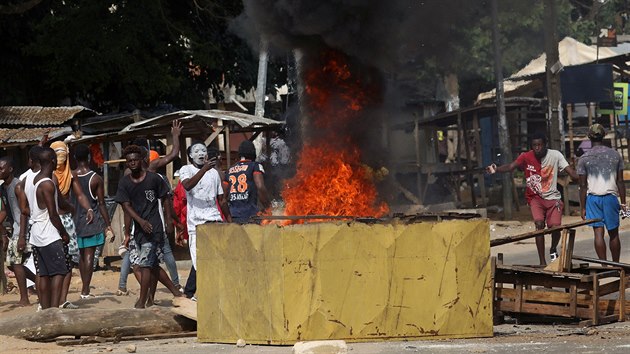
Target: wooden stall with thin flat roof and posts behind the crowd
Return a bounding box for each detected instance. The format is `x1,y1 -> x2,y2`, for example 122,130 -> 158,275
72,110 -> 284,195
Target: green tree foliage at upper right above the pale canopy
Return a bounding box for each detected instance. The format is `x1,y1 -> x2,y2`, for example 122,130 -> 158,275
452,0 -> 627,106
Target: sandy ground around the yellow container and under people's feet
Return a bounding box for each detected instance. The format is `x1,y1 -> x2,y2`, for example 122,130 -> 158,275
0,208 -> 630,353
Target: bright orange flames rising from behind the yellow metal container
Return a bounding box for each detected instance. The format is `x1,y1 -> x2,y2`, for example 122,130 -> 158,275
282,51 -> 389,221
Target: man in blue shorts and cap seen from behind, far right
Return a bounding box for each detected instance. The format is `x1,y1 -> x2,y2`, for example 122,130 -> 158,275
577,123 -> 627,262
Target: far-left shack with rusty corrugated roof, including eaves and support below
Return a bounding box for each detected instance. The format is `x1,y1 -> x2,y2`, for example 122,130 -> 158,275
0,106 -> 98,171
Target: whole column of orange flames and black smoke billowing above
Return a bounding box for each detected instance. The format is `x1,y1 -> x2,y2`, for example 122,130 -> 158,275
235,0 -> 474,223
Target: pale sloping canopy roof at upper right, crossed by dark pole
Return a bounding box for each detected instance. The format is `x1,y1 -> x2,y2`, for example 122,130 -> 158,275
477,37 -> 630,103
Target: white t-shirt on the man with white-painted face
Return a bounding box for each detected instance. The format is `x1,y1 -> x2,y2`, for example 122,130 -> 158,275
179,165 -> 223,233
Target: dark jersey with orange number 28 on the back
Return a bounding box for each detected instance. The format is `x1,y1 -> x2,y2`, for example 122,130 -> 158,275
225,160 -> 265,218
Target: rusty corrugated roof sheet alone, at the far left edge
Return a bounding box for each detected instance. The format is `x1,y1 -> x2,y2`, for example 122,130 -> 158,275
0,106 -> 97,126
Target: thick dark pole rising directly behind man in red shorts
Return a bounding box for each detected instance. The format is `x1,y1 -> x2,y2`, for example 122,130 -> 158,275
543,0 -> 564,152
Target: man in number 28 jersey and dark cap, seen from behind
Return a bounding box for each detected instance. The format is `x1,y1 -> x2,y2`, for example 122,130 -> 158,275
223,140 -> 271,224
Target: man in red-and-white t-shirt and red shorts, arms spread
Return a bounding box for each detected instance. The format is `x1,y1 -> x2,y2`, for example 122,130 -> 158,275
486,134 -> 578,265
